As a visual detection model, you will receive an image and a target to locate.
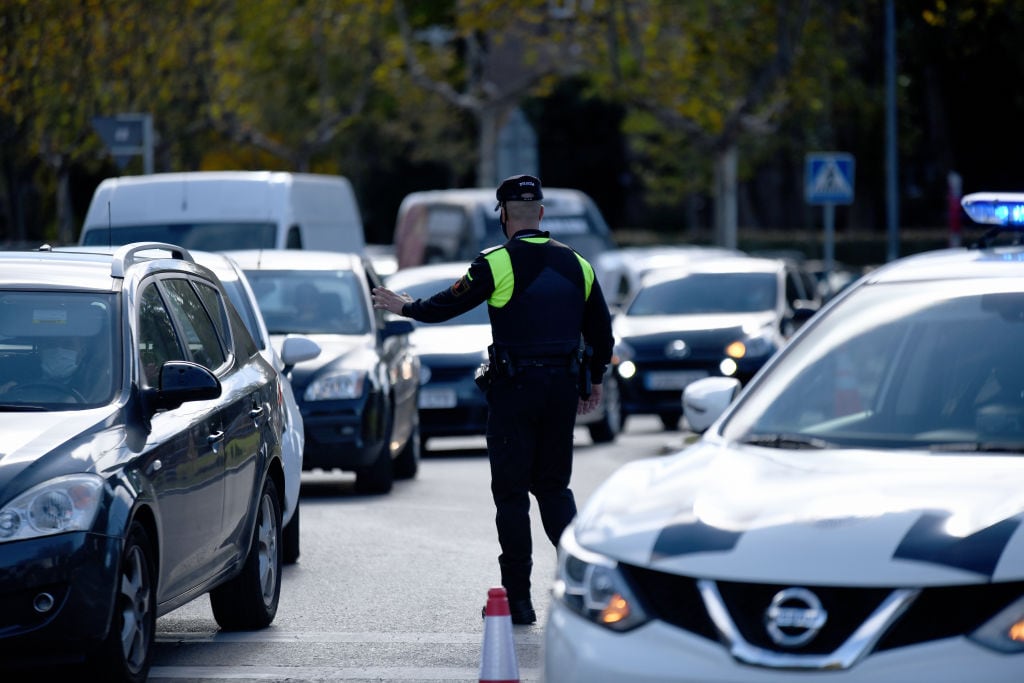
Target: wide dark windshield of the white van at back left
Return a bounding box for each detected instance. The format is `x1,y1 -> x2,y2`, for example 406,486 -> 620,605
84,222 -> 276,251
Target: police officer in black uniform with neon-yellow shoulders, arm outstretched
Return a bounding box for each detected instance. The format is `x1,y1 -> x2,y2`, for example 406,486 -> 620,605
373,175 -> 612,624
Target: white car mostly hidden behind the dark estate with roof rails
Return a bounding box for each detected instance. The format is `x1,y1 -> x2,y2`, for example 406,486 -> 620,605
191,251 -> 321,564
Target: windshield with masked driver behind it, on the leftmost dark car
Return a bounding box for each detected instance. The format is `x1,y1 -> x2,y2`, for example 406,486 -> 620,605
0,291 -> 122,411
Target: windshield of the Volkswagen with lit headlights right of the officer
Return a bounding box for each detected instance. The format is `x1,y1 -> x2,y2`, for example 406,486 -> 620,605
627,272 -> 778,315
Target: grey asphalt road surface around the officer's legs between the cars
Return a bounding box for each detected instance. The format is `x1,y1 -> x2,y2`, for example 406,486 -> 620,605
150,417 -> 687,683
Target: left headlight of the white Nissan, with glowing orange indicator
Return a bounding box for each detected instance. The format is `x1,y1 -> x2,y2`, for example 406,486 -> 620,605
552,528 -> 649,631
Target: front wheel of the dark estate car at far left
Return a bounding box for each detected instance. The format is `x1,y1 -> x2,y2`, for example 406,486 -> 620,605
89,521 -> 157,683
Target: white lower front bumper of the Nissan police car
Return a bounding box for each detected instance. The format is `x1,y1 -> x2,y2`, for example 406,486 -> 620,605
544,600 -> 1024,683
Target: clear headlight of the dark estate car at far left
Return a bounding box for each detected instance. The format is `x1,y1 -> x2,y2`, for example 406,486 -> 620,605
0,474 -> 103,543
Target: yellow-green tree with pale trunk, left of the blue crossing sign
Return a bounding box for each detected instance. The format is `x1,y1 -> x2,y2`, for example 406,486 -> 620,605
591,0 -> 828,248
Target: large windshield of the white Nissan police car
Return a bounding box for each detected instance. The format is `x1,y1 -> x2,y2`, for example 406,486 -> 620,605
723,279 -> 1024,453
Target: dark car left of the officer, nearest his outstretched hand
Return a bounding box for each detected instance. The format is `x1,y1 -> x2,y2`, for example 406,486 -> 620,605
224,249 -> 420,494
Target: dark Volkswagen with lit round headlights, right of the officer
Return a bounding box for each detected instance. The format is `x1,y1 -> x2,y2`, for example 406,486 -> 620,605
612,256 -> 817,429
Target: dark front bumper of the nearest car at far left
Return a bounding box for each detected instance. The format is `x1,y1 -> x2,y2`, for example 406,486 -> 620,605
0,532 -> 122,664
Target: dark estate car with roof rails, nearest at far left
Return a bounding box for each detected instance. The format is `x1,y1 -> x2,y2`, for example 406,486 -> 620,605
0,243 -> 284,681
